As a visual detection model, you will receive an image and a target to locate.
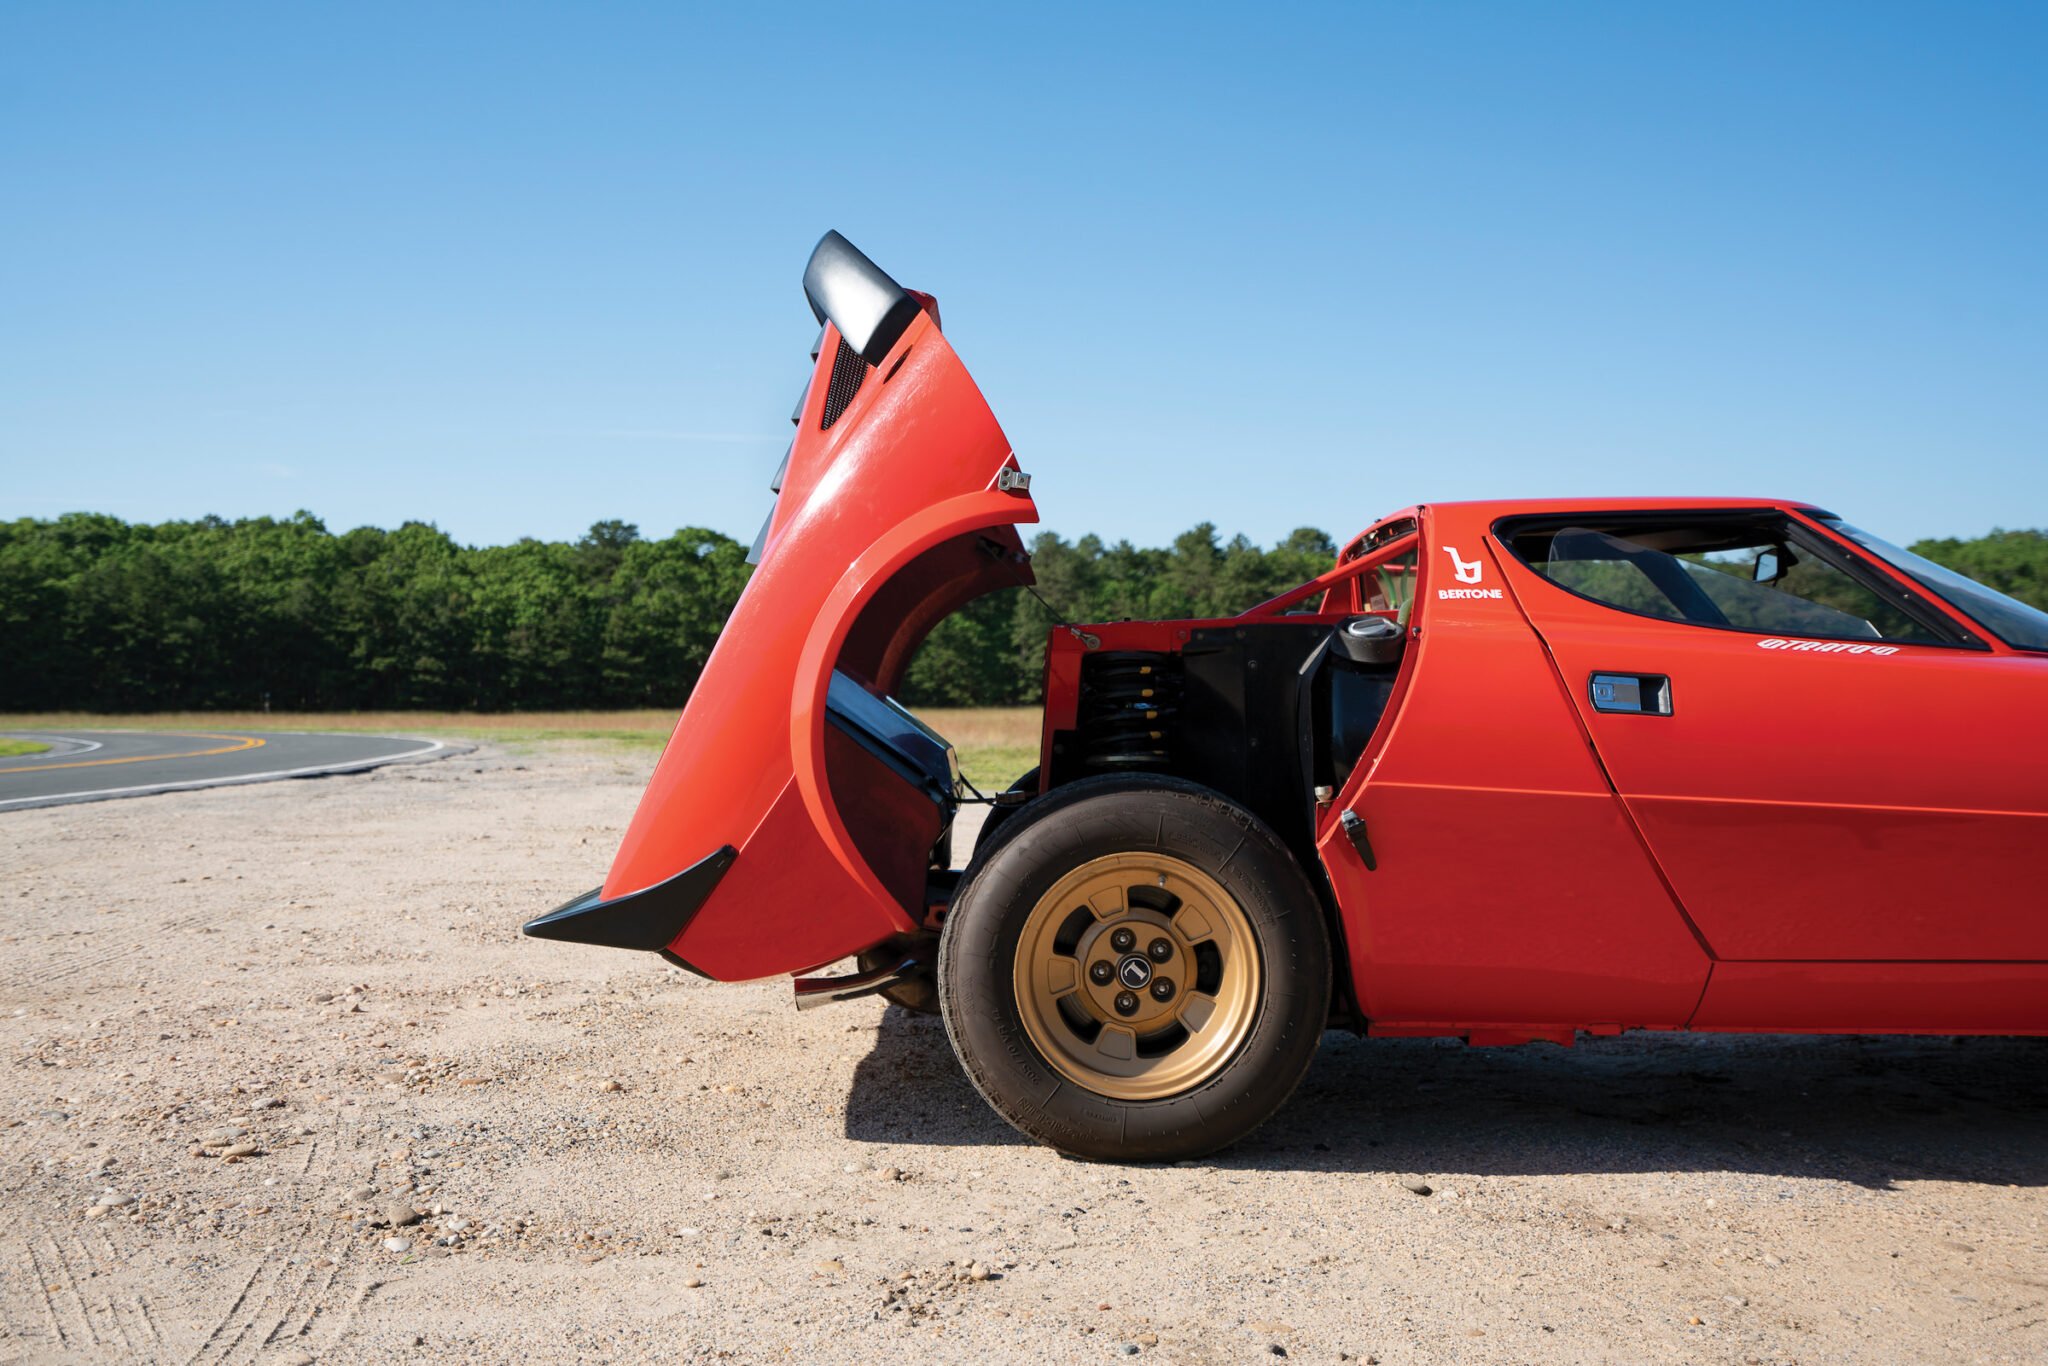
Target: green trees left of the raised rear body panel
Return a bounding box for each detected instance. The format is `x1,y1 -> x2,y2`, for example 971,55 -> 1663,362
0,512 -> 748,711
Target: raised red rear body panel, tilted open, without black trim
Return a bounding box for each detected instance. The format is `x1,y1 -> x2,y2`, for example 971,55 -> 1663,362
604,301 -> 1038,981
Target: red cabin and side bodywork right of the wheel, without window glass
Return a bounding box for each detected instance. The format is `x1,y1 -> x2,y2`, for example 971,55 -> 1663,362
1294,500 -> 2048,1040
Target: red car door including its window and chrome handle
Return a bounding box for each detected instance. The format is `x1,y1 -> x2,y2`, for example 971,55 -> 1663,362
1499,508 -> 2048,963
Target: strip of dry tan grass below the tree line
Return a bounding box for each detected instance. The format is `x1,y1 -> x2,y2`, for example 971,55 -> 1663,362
0,707 -> 1038,791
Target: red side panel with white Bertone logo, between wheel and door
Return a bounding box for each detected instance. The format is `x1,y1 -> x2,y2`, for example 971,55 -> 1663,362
1317,504 -> 1708,1023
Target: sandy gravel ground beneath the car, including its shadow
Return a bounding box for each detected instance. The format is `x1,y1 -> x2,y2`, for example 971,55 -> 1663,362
0,743 -> 2048,1366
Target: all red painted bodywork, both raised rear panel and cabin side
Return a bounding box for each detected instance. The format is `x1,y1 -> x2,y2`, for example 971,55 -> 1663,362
585,282 -> 2048,1042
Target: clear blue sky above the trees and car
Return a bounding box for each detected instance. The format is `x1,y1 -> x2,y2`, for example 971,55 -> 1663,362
0,0 -> 2048,543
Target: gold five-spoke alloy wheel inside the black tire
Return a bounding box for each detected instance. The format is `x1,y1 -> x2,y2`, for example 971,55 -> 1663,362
1014,854 -> 1260,1100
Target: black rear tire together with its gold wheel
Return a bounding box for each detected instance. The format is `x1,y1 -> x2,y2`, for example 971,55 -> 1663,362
938,776 -> 1331,1161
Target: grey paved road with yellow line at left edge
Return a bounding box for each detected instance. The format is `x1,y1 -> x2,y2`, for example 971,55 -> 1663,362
0,731 -> 465,811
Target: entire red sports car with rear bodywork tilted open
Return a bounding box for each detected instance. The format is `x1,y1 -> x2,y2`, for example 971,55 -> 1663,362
526,233 -> 2048,1159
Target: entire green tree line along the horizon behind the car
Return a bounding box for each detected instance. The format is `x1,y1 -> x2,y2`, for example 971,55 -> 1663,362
0,512 -> 2048,713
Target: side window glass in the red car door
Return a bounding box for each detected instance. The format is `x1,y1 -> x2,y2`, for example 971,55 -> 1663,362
1509,516 -> 1954,645
